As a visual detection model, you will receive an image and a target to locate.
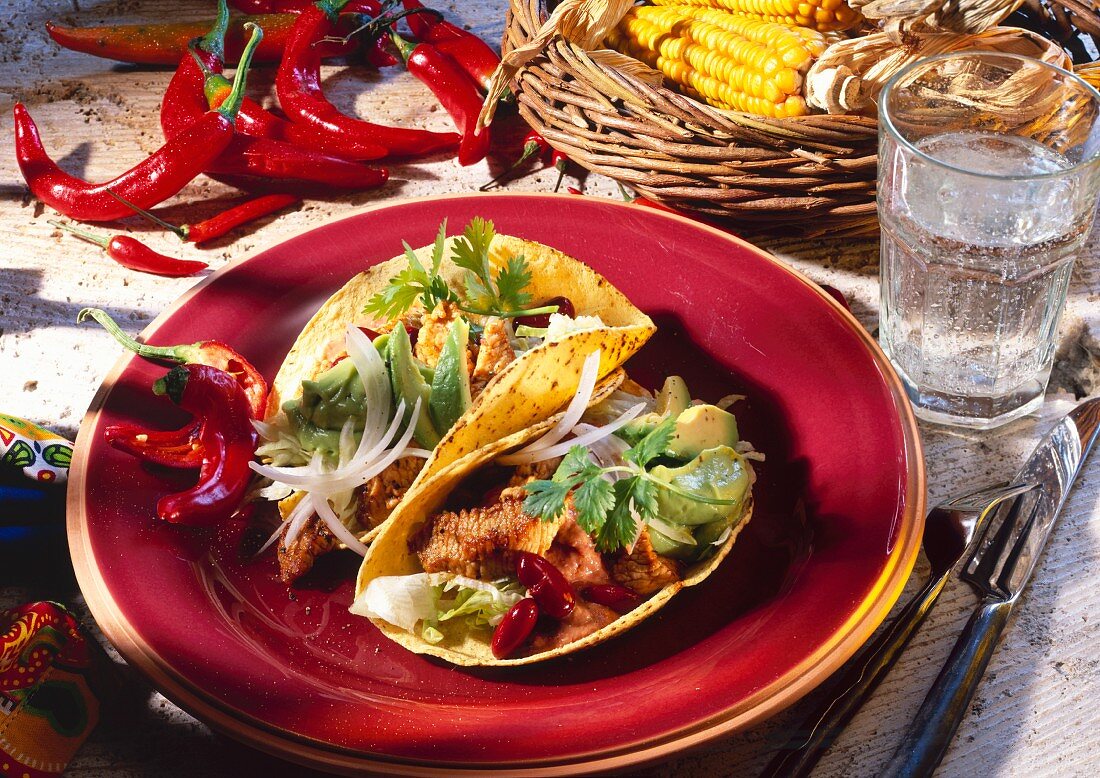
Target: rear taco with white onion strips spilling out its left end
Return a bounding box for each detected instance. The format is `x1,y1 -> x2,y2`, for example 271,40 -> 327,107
253,219 -> 655,582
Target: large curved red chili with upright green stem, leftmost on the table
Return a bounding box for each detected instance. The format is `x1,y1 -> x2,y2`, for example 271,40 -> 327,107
14,26 -> 263,221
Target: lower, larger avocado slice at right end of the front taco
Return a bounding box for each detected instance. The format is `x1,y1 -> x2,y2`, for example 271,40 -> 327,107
649,446 -> 751,525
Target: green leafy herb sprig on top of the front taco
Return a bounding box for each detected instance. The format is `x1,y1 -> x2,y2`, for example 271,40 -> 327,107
524,416 -> 738,551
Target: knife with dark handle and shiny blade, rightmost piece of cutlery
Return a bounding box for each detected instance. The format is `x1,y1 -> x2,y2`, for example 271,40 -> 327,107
881,397 -> 1100,778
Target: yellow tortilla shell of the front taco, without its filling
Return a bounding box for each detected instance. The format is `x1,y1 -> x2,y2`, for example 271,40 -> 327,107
355,415 -> 752,667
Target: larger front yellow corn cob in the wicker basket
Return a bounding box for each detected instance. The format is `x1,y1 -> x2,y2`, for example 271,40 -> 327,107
608,6 -> 825,118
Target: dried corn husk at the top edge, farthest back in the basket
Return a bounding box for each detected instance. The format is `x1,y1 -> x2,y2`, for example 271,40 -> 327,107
848,0 -> 1024,41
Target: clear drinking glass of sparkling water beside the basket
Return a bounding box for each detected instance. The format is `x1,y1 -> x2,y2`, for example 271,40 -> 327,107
878,52 -> 1100,428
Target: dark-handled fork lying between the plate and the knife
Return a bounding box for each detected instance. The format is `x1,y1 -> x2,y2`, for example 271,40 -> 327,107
761,484 -> 1032,778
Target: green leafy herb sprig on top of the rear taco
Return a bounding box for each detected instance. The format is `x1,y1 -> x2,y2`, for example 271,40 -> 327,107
364,217 -> 558,319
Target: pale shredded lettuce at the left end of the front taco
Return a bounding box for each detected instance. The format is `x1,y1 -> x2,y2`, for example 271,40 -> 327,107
349,572 -> 525,643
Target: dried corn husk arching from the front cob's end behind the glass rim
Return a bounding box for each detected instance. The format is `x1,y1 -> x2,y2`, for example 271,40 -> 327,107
805,28 -> 1073,114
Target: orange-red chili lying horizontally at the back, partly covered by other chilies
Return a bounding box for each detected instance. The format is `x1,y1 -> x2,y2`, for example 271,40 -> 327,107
46,13 -> 355,65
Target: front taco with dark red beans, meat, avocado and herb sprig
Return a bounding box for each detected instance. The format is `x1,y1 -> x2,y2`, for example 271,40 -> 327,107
351,365 -> 760,666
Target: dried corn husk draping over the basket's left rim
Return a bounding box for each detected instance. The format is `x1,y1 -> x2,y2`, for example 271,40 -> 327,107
477,0 -> 634,129
